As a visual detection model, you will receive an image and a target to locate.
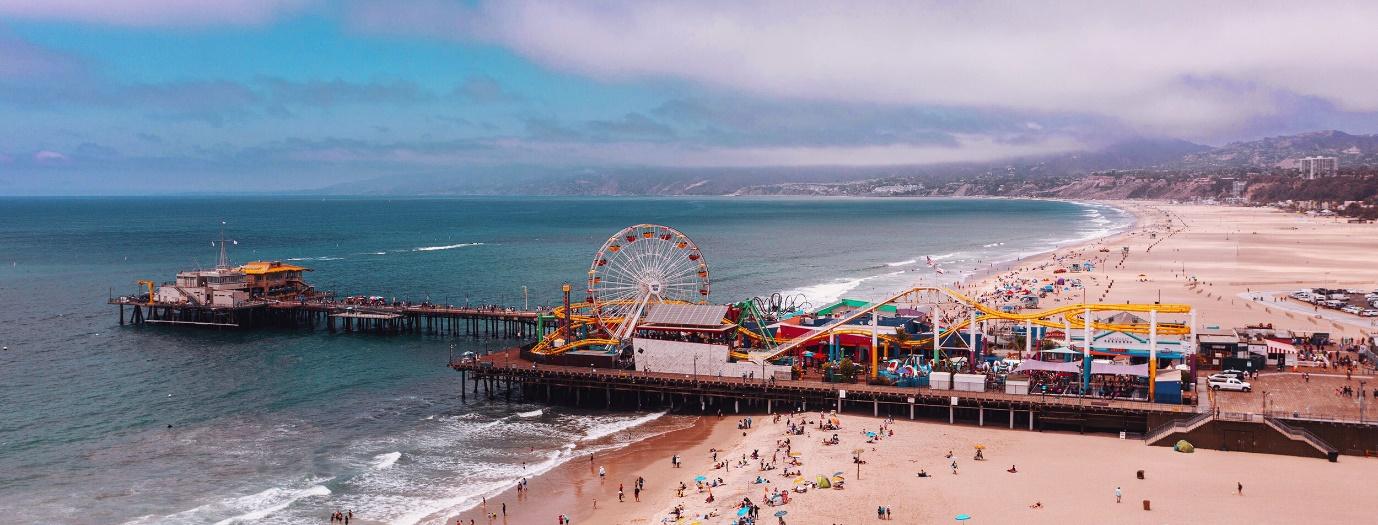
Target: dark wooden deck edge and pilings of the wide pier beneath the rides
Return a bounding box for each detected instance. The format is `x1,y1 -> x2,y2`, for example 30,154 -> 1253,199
451,349 -> 1197,435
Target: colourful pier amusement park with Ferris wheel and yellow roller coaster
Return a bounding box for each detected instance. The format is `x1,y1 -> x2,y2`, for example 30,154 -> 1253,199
531,225 -> 1196,398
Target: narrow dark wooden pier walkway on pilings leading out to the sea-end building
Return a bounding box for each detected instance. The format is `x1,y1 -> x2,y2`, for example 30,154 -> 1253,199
109,298 -> 553,340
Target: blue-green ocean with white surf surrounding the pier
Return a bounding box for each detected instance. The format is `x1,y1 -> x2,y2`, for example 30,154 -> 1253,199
0,197 -> 1131,524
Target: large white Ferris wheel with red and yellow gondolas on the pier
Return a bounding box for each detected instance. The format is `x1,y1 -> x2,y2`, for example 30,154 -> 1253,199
588,225 -> 708,339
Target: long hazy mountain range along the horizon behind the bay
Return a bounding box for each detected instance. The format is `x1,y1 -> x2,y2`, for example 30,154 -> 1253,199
322,131 -> 1378,198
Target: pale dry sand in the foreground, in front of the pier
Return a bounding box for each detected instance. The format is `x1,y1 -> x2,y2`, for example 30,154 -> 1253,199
652,412 -> 1378,524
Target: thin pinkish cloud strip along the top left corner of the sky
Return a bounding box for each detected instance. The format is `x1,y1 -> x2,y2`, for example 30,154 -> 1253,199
0,0 -> 316,28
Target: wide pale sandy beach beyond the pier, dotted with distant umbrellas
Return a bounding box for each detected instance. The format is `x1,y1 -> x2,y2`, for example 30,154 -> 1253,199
963,201 -> 1378,338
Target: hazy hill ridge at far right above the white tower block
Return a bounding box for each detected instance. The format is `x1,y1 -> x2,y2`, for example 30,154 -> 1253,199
1181,130 -> 1378,168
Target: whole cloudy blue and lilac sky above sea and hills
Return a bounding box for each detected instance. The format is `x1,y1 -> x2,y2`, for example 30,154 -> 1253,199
0,0 -> 1378,194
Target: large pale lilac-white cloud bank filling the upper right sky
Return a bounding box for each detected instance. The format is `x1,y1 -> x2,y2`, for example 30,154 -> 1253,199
351,0 -> 1378,136
